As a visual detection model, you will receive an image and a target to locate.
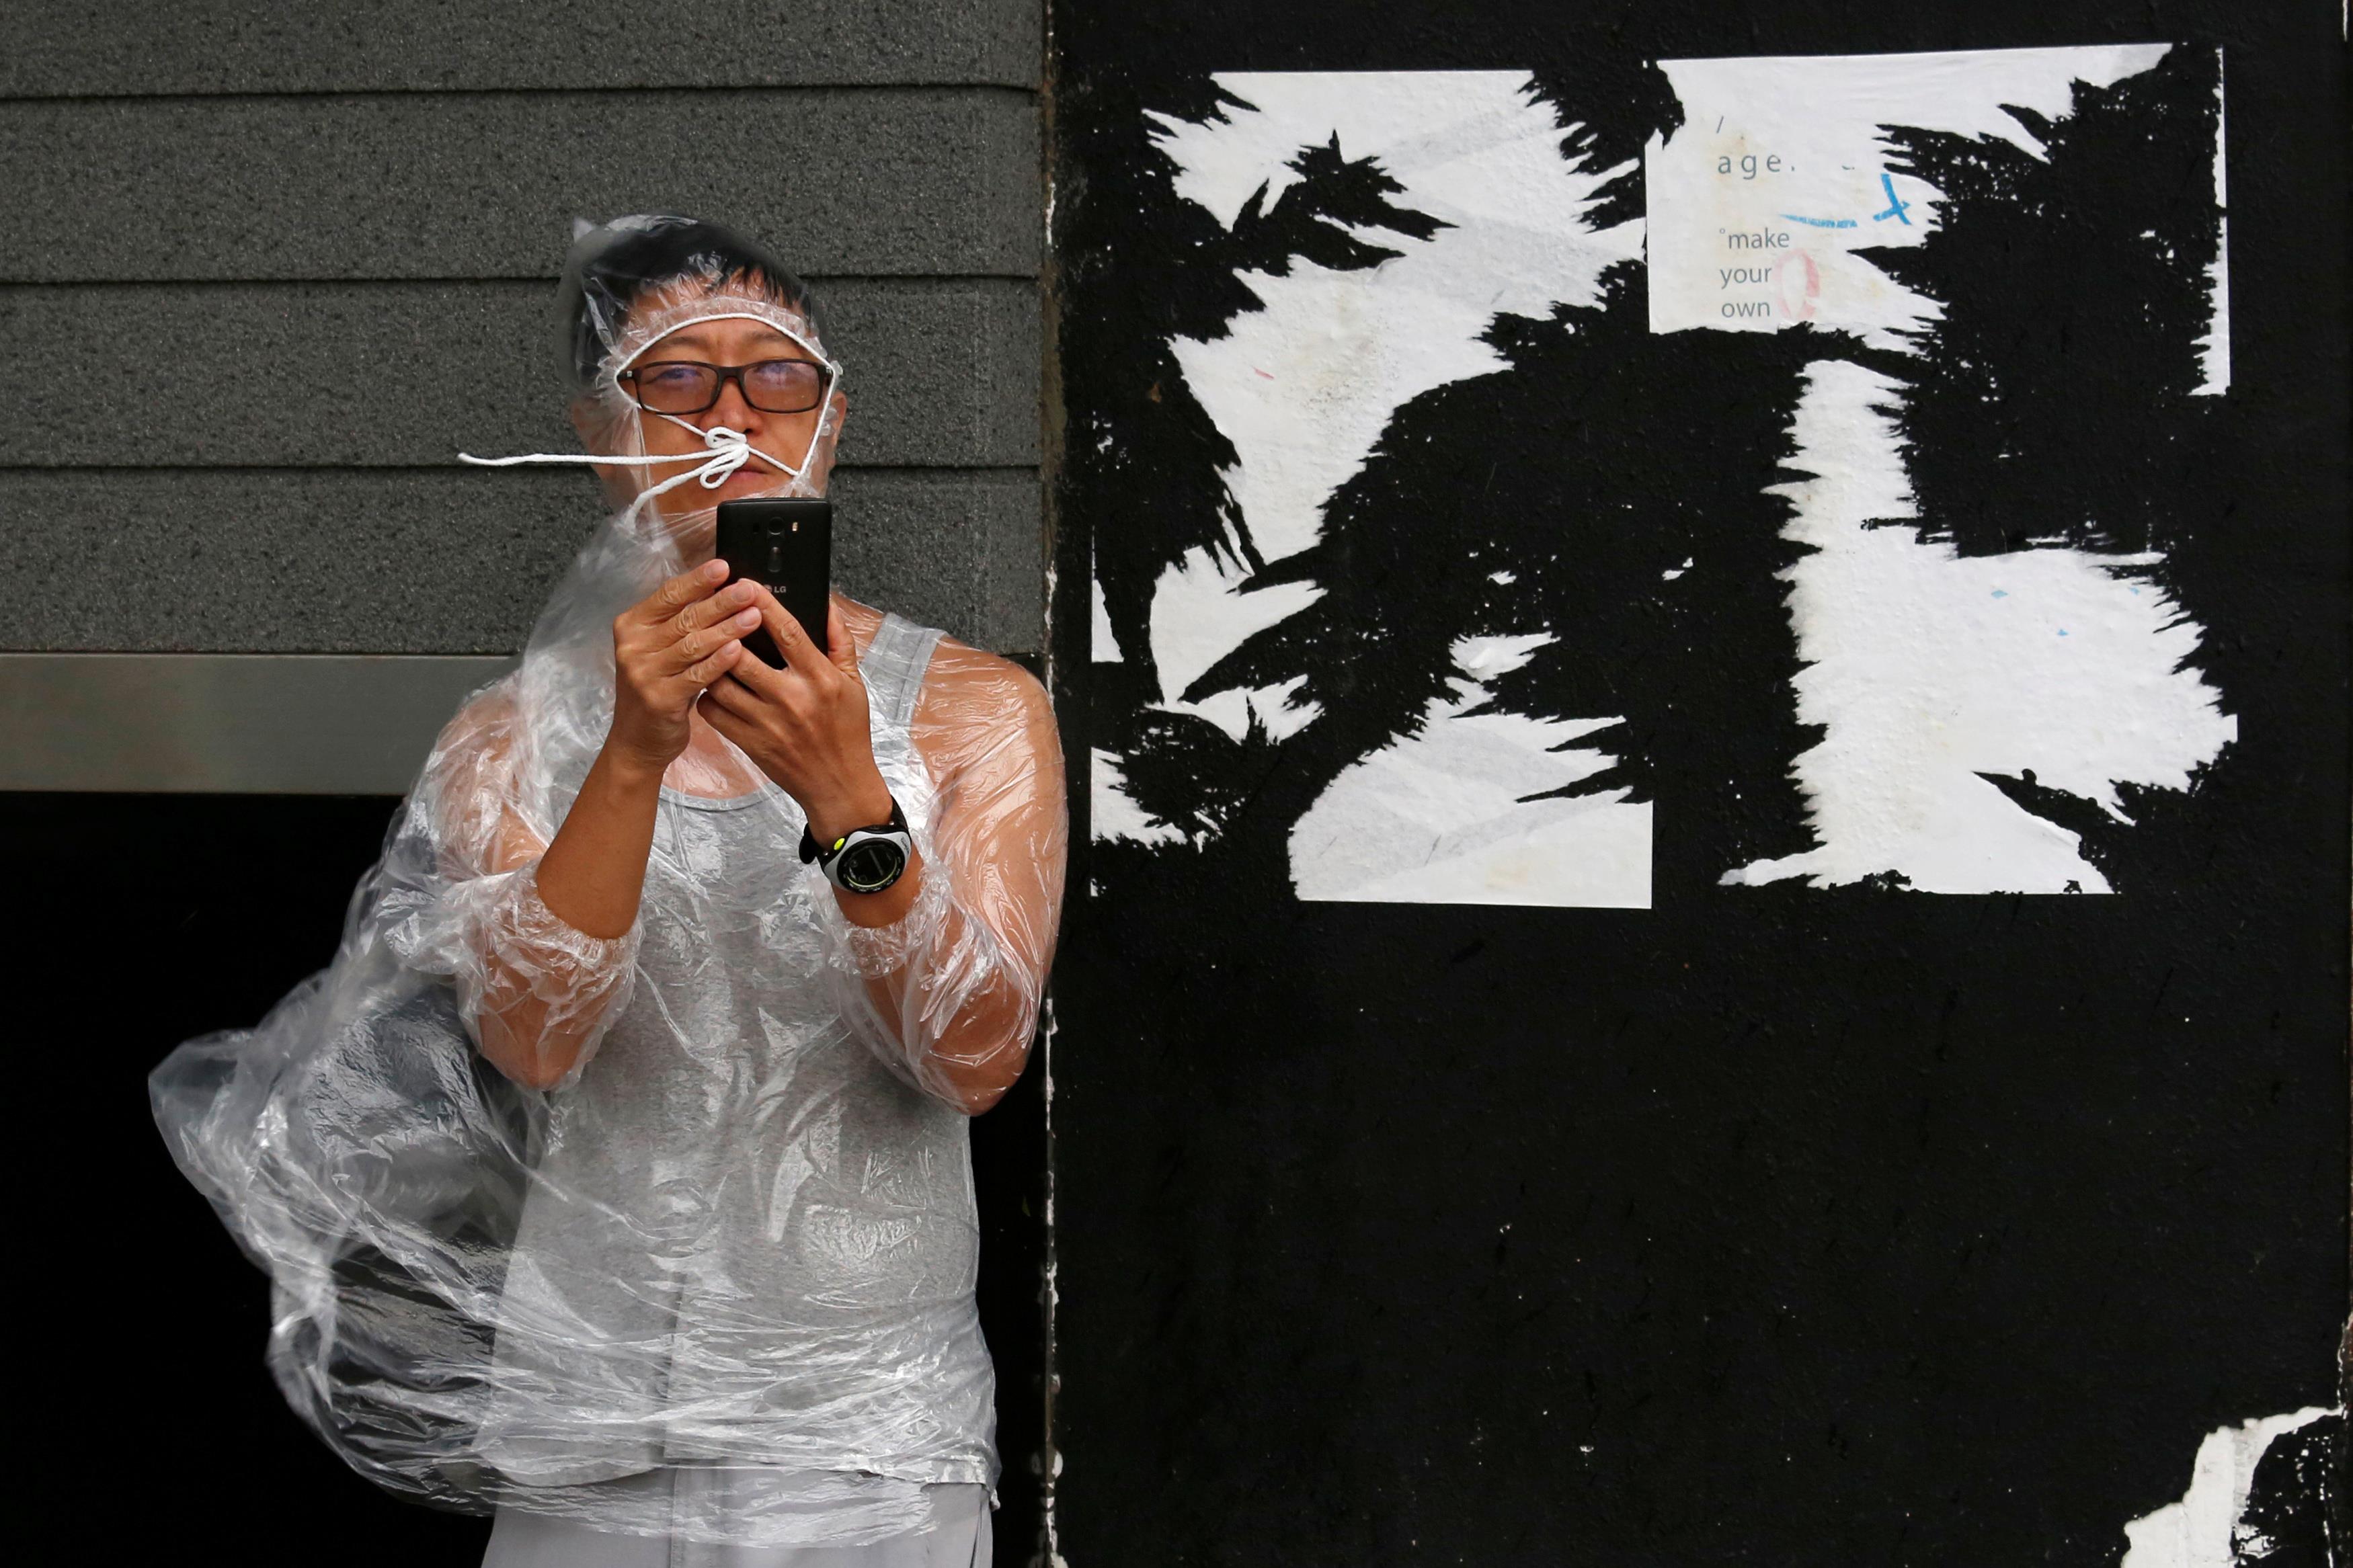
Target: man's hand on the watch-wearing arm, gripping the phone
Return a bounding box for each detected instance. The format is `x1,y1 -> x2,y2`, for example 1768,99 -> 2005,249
701,583 -> 889,841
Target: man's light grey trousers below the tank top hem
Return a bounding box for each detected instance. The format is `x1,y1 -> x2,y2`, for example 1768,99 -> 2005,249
483,1467 -> 991,1568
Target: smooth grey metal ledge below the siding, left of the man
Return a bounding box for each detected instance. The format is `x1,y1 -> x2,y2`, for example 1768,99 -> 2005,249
0,653 -> 516,794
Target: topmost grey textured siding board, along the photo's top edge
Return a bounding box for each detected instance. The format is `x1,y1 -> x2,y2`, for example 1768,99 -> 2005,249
0,0 -> 1043,96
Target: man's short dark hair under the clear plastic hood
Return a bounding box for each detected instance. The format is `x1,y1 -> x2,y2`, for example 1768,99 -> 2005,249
555,214 -> 826,393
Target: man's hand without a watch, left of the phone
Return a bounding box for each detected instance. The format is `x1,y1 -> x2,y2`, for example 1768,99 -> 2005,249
605,562 -> 760,774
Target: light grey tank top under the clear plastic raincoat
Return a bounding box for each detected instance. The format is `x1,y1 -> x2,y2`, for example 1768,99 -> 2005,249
478,616 -> 998,1486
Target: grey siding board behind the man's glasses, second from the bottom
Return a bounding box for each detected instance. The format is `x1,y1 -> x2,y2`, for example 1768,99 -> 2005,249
0,278 -> 1040,468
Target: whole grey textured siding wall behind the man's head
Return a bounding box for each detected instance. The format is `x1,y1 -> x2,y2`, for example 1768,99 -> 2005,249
0,0 -> 1043,670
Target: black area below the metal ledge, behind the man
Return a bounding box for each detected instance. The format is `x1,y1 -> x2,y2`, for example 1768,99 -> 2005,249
0,794 -> 1045,1568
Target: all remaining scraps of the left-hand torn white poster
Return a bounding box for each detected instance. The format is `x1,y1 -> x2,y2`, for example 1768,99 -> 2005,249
1153,71 -> 1650,907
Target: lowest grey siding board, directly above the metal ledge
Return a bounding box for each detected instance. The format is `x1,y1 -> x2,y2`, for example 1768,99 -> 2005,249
0,468 -> 1043,653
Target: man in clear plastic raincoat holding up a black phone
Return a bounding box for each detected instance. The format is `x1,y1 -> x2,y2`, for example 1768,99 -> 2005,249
158,216 -> 1066,1568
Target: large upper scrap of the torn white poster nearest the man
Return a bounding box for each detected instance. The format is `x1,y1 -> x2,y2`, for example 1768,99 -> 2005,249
1156,71 -> 1640,573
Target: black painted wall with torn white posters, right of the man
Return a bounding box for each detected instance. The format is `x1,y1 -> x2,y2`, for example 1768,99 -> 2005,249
1052,0 -> 2348,1568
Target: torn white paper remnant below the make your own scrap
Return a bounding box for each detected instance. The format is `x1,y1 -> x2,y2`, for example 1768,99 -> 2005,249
1725,360 -> 2238,893
